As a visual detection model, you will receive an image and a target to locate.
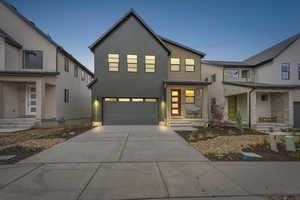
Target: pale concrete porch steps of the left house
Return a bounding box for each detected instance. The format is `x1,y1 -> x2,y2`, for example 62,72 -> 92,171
0,118 -> 38,128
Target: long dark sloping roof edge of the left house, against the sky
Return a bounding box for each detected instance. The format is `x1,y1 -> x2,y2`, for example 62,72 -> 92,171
0,0 -> 94,76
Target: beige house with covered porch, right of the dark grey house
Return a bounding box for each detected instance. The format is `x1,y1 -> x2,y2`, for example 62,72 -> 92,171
202,34 -> 300,129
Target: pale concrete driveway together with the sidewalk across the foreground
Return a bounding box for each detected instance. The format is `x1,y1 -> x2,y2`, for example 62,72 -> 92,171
0,126 -> 300,200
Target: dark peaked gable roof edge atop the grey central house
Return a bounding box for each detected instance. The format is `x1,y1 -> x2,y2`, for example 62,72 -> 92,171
89,8 -> 171,54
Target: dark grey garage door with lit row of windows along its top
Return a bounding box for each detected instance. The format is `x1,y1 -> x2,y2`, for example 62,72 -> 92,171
103,98 -> 159,125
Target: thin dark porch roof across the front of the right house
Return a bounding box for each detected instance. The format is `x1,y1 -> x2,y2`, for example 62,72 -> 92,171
223,81 -> 300,89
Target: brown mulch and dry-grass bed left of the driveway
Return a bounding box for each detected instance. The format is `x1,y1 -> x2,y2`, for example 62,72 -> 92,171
0,127 -> 91,165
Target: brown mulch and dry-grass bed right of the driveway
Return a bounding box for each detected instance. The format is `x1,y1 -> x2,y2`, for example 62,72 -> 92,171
177,127 -> 300,161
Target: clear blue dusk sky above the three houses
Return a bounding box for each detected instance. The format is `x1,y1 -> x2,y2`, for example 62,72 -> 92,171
6,0 -> 300,71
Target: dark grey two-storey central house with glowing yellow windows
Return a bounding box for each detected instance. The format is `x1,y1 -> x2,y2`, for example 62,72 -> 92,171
89,10 -> 209,125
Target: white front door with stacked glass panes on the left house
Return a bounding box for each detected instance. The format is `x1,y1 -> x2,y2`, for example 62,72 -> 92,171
26,85 -> 37,115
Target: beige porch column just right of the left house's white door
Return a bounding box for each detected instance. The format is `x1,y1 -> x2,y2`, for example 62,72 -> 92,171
35,79 -> 45,120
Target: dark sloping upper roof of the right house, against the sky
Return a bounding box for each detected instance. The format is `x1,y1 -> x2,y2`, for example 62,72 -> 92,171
244,33 -> 300,66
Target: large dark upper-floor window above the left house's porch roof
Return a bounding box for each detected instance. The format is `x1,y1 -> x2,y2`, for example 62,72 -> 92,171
23,50 -> 43,69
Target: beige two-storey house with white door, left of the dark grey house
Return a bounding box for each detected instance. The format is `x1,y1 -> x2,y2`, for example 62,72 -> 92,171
0,1 -> 93,127
